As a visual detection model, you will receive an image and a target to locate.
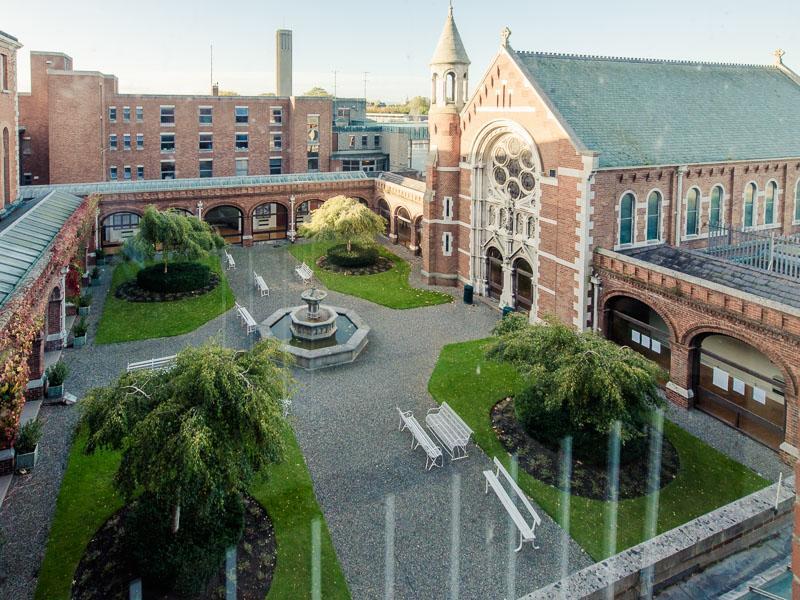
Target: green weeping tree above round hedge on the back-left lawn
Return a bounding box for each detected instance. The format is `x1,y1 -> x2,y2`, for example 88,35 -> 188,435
126,205 -> 224,273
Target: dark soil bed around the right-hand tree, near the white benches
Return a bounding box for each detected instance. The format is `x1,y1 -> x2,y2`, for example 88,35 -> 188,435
491,398 -> 680,500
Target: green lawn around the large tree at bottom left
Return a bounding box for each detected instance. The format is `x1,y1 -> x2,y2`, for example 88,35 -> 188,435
36,428 -> 350,600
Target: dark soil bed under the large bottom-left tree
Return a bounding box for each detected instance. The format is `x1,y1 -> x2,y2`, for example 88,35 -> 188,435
72,497 -> 277,600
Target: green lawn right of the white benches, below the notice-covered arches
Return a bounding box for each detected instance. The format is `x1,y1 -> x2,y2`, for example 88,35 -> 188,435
428,340 -> 769,561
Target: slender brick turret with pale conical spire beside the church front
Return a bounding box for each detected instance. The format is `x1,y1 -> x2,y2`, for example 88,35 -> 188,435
422,3 -> 470,285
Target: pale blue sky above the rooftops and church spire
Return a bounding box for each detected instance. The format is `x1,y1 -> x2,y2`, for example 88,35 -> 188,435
6,0 -> 800,100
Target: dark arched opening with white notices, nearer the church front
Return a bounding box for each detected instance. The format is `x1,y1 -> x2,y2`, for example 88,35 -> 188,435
605,296 -> 670,371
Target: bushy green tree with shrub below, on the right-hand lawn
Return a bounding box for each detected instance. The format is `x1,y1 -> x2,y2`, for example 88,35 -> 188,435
487,318 -> 663,448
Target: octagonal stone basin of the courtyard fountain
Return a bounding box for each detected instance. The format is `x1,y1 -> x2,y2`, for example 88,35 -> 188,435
258,305 -> 370,370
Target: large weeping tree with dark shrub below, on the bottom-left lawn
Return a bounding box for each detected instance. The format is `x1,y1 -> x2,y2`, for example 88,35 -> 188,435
81,340 -> 293,593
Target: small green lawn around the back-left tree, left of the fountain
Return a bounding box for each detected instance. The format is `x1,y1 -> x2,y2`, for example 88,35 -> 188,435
94,256 -> 235,344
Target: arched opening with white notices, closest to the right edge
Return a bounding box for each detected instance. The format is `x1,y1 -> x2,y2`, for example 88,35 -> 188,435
692,333 -> 786,449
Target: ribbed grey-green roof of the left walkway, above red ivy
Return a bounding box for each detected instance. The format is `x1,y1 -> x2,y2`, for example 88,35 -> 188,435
0,191 -> 83,306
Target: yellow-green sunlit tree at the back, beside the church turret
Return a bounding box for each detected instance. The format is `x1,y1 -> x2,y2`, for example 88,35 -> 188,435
299,196 -> 386,252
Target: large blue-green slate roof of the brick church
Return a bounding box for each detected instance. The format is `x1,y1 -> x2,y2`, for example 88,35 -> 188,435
516,52 -> 800,168
